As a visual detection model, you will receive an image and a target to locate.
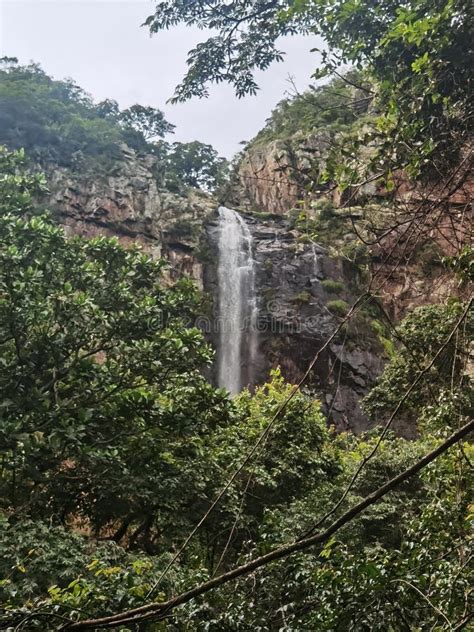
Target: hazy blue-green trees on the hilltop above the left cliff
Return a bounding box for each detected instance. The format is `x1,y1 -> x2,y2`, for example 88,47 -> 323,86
0,58 -> 227,192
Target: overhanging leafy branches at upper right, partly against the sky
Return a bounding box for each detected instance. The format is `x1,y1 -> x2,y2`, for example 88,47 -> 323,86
146,0 -> 473,182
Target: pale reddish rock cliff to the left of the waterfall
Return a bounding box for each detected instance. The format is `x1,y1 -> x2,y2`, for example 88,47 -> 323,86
47,146 -> 216,287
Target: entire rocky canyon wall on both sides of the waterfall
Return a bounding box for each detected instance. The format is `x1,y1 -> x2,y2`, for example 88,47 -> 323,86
43,134 -> 465,434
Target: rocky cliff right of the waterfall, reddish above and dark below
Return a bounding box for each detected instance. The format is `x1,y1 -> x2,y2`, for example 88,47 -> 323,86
218,133 -> 474,435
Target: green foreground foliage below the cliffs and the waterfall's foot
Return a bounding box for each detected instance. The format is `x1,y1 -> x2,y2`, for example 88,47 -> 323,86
0,149 -> 472,632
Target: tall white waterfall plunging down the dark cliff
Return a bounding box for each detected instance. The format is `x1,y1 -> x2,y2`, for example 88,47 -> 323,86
217,206 -> 258,395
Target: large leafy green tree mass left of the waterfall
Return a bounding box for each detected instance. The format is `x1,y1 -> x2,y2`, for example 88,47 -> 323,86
0,150 -> 233,539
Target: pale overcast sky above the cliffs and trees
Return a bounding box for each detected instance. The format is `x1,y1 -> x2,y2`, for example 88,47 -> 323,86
0,0 -> 319,157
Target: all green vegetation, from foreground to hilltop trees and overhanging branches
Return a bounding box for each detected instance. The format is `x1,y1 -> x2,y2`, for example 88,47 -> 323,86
0,0 -> 474,632
